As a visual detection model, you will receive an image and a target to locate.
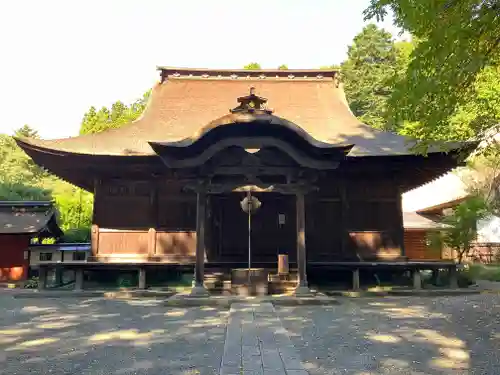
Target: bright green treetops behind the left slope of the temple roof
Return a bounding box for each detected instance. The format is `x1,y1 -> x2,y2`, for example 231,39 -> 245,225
80,91 -> 151,135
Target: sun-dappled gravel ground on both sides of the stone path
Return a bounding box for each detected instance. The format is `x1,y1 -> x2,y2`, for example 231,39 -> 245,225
0,291 -> 500,375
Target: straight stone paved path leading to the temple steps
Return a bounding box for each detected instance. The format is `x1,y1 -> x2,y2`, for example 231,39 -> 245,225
220,303 -> 308,375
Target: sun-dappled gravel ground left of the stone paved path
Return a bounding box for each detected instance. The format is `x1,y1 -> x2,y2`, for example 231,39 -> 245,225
0,291 -> 227,375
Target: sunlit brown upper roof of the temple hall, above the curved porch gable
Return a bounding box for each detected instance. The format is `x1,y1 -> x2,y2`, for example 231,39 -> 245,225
13,68 -> 432,156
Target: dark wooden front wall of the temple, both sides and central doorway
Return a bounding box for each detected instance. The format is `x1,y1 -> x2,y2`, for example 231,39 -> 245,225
92,174 -> 403,263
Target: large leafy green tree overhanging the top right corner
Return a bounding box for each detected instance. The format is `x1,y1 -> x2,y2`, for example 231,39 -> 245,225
365,0 -> 500,139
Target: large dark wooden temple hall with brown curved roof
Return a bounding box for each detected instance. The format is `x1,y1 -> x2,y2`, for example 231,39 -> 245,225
17,67 -> 472,292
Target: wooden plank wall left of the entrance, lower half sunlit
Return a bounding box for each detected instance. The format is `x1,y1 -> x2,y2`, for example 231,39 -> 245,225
92,180 -> 196,263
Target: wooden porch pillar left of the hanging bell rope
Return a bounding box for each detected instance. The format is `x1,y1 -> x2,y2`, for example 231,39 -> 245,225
191,190 -> 208,296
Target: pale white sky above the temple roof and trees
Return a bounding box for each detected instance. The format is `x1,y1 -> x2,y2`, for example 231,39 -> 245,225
0,0 -> 397,138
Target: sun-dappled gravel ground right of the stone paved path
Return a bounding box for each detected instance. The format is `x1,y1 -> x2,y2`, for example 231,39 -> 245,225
277,294 -> 500,375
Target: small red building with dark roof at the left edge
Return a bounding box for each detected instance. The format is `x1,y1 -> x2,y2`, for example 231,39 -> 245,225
0,202 -> 62,281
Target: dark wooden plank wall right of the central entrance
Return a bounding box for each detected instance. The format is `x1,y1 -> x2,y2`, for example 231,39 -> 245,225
306,178 -> 404,261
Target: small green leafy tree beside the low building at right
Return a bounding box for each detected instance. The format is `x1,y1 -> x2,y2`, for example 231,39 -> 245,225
429,196 -> 487,263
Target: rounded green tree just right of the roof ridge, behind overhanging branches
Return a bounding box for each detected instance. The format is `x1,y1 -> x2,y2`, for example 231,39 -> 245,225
341,24 -> 399,129
